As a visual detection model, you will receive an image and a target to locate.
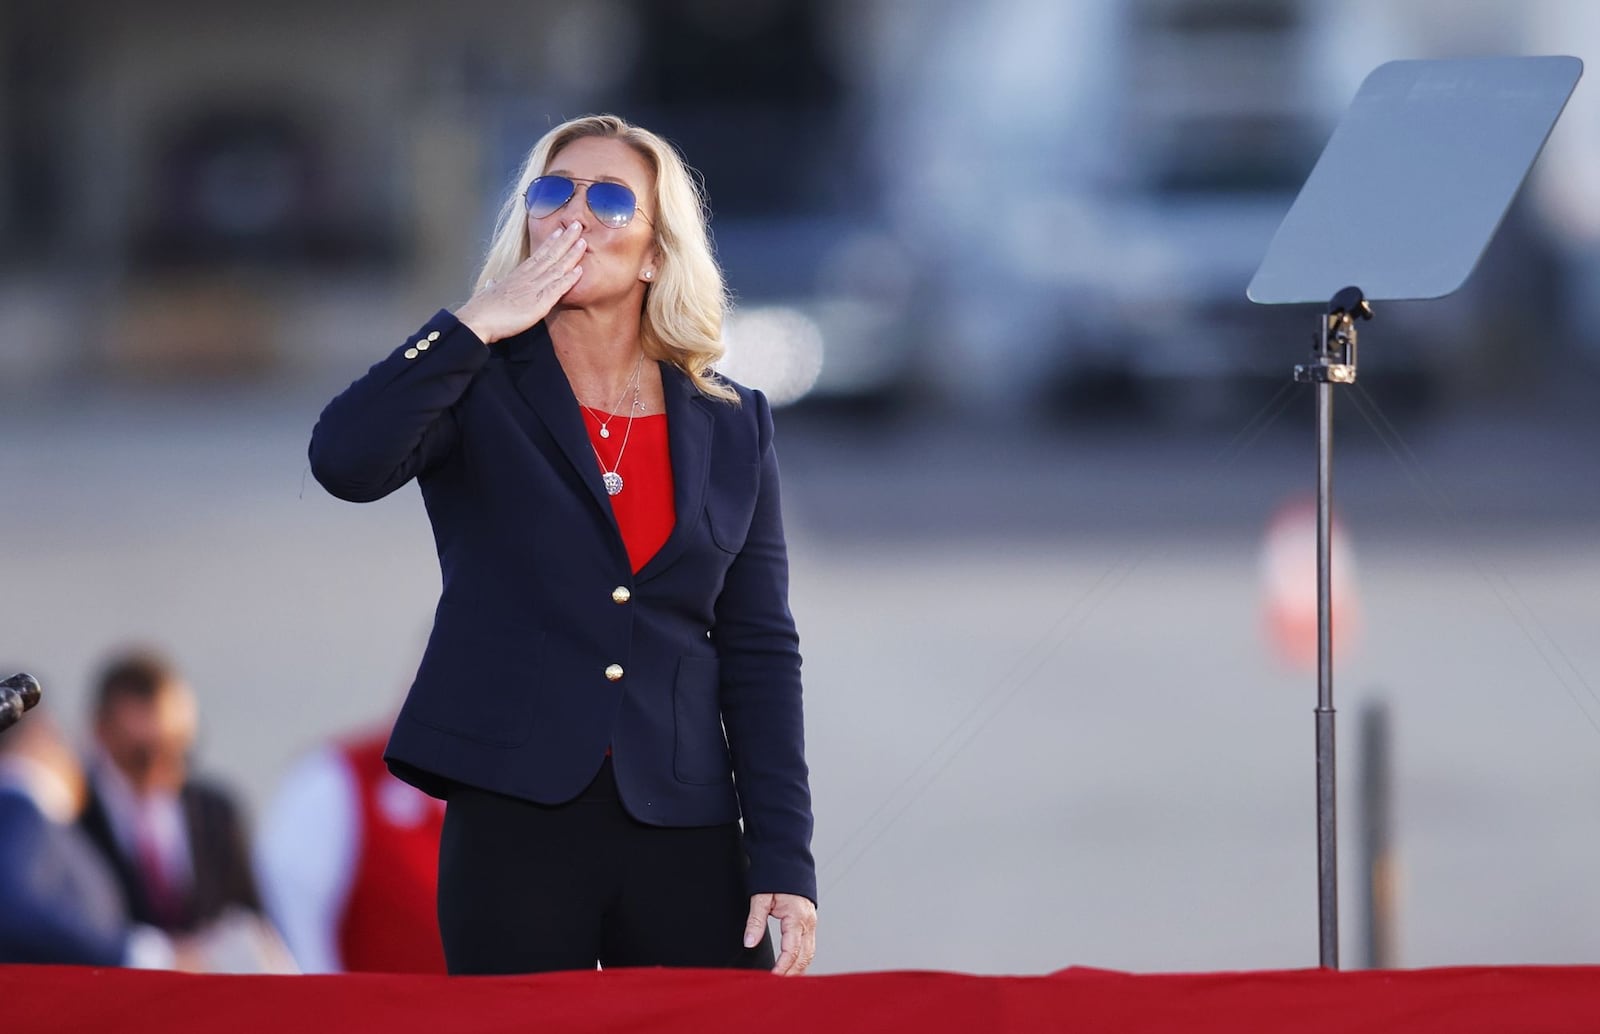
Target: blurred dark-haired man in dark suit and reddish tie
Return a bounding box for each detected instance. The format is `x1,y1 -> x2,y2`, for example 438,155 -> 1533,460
80,651 -> 261,933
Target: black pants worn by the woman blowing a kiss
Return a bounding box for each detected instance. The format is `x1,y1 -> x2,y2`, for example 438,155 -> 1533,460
438,759 -> 773,973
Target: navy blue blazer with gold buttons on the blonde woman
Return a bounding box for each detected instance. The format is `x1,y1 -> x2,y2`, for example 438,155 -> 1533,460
310,311 -> 816,901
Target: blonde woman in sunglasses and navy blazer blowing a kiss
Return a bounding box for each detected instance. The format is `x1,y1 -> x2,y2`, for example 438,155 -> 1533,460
310,115 -> 816,973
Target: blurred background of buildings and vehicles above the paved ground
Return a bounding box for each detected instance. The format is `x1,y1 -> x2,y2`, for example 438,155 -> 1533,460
0,0 -> 1600,415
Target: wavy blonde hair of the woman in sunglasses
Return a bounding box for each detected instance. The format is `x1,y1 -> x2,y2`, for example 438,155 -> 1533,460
477,115 -> 739,402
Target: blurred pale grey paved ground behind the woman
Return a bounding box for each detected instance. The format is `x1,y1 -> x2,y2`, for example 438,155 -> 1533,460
0,376 -> 1600,972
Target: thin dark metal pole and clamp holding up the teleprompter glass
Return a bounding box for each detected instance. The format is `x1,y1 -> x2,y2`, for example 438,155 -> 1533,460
1294,287 -> 1373,970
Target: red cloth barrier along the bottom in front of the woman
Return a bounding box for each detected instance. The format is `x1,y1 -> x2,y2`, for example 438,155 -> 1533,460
0,965 -> 1600,1034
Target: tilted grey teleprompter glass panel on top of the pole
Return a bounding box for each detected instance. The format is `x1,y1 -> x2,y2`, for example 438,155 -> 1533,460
1246,56 -> 1582,304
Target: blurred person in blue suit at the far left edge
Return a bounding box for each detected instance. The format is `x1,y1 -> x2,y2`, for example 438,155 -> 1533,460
0,712 -> 174,967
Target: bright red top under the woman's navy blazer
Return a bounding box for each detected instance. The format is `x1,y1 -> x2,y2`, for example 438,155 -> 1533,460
584,408 -> 677,575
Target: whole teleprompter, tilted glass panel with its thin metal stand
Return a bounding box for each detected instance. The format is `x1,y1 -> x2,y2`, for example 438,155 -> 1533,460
1245,54 -> 1584,968
